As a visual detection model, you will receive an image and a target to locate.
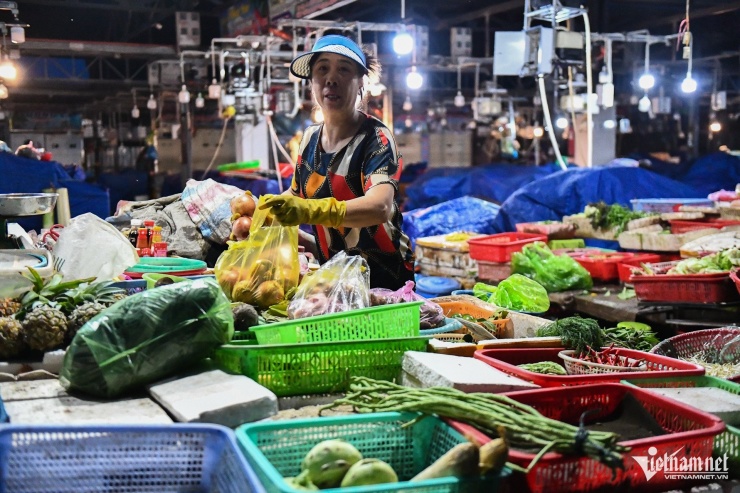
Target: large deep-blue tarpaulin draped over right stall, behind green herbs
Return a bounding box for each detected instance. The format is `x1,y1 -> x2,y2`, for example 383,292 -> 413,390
494,166 -> 706,232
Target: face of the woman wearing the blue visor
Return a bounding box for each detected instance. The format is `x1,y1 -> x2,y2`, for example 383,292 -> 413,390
311,53 -> 362,115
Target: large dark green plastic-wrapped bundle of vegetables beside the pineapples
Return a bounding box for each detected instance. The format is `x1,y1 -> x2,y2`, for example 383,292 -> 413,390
59,278 -> 234,397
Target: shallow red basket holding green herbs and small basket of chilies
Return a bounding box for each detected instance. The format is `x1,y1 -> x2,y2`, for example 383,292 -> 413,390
474,348 -> 704,387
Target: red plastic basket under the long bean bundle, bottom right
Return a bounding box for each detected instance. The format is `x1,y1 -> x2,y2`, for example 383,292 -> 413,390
451,384 -> 725,493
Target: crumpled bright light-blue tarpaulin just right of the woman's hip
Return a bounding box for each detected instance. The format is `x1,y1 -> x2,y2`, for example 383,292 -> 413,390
403,197 -> 499,246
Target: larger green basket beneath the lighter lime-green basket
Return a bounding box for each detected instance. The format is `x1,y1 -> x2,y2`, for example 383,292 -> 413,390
214,337 -> 429,396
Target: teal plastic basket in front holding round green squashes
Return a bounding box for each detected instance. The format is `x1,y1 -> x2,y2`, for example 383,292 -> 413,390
236,413 -> 506,493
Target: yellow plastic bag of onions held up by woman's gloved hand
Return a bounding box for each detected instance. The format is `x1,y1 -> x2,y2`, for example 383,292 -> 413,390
214,198 -> 300,308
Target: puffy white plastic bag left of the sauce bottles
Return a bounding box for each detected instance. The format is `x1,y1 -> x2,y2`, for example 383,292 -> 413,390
54,213 -> 139,281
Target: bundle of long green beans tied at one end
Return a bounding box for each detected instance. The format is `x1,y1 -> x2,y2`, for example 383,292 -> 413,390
321,377 -> 629,470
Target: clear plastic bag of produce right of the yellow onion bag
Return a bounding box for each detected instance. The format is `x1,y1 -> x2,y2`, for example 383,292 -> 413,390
288,252 -> 370,319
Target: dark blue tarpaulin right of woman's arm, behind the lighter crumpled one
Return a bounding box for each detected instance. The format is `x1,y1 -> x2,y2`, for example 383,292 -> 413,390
404,164 -> 560,210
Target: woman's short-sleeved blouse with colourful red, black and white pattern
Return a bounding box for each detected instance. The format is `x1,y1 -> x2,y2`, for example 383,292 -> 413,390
291,115 -> 414,289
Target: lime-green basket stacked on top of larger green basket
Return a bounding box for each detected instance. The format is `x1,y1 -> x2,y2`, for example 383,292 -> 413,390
250,302 -> 422,344
